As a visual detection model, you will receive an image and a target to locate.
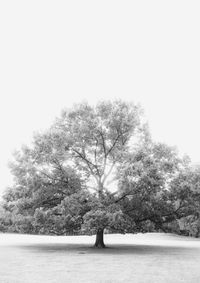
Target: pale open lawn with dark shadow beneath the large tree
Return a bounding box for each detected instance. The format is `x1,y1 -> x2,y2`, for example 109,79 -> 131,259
0,233 -> 200,283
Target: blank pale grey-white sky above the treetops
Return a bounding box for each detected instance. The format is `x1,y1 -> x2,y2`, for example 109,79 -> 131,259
0,0 -> 200,197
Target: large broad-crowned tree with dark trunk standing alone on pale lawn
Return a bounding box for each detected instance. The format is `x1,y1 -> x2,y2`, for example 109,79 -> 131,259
4,101 -> 198,247
